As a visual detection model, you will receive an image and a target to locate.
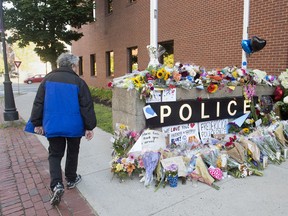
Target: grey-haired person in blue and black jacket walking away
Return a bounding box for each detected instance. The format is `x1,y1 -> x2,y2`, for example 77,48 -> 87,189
30,53 -> 97,205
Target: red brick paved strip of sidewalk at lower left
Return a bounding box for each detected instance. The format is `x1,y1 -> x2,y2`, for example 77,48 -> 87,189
0,98 -> 96,216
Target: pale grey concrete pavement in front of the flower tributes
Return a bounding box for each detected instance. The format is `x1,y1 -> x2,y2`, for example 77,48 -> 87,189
1,90 -> 288,216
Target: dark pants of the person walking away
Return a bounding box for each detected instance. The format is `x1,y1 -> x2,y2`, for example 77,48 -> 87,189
48,137 -> 81,190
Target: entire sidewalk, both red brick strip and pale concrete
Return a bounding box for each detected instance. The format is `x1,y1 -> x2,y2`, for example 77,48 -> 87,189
0,93 -> 288,216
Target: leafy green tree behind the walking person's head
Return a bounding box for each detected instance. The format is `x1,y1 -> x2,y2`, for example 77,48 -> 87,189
4,0 -> 94,69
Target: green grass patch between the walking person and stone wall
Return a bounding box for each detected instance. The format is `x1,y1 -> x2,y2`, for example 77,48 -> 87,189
94,103 -> 114,134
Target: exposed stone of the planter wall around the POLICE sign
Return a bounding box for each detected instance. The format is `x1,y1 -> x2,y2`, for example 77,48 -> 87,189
112,86 -> 275,131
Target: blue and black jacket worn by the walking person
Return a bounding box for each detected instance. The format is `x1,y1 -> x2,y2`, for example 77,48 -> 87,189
30,68 -> 97,138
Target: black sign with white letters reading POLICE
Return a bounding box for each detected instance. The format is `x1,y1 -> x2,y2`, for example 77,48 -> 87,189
146,97 -> 256,128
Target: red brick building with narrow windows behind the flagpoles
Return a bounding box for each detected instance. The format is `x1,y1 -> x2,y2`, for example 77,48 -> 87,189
72,0 -> 288,87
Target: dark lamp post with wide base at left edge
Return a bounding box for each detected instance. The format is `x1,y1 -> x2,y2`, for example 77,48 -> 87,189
0,0 -> 19,121
